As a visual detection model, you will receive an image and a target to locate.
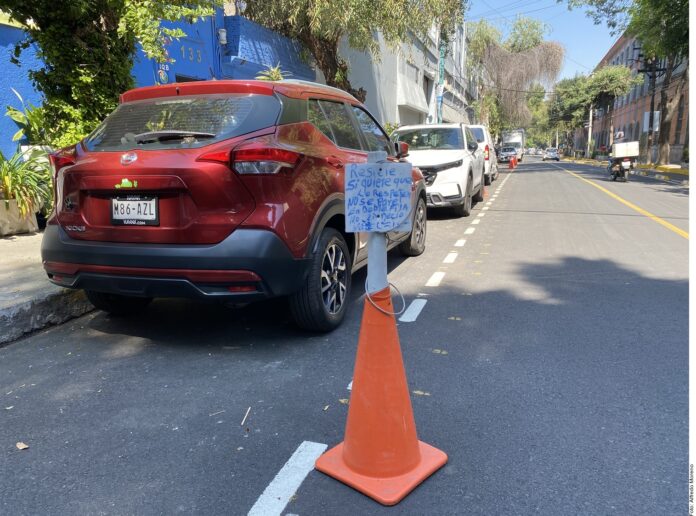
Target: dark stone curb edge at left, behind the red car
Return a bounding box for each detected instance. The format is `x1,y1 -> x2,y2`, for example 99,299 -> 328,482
0,287 -> 94,344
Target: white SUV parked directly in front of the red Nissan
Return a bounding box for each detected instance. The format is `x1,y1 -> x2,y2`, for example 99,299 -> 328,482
391,124 -> 484,217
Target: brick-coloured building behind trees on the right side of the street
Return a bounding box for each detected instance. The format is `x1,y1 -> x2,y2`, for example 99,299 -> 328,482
576,35 -> 689,163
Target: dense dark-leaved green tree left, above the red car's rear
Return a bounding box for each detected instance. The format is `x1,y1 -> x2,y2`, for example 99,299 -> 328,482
0,0 -> 215,146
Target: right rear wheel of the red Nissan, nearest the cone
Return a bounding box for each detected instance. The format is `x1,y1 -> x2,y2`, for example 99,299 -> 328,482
290,228 -> 352,332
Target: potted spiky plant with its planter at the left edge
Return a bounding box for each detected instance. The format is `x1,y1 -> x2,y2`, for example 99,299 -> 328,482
0,150 -> 52,236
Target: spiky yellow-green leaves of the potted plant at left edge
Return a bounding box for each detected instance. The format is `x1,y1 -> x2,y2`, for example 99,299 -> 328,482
0,147 -> 52,216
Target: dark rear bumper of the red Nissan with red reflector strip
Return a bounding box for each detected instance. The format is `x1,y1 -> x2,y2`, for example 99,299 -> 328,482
41,225 -> 309,302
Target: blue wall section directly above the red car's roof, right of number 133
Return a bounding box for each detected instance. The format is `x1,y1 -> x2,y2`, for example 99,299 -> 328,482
222,16 -> 316,81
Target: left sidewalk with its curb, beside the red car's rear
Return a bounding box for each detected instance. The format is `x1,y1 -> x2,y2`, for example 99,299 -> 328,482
0,233 -> 93,344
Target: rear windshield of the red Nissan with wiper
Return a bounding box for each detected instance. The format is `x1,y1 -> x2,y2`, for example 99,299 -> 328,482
84,94 -> 281,151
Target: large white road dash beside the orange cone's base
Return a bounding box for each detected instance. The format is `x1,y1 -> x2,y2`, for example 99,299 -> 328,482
248,441 -> 327,516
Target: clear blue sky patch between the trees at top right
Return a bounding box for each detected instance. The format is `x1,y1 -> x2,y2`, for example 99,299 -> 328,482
465,0 -> 618,79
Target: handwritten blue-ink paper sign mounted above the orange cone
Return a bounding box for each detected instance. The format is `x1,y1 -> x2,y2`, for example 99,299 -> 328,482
345,162 -> 412,233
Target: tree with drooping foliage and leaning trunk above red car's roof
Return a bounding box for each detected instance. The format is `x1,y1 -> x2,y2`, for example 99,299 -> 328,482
243,0 -> 465,97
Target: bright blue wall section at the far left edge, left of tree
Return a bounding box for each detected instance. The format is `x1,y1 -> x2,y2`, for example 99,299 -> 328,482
0,24 -> 42,157
